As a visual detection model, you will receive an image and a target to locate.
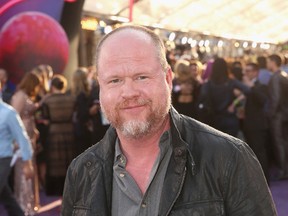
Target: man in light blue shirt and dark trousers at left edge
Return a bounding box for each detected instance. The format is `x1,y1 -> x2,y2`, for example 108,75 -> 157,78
0,82 -> 33,216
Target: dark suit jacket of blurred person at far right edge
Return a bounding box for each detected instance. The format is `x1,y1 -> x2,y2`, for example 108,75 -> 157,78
268,71 -> 288,120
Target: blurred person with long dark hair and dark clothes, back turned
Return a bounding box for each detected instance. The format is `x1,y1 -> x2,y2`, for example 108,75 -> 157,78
199,58 -> 249,137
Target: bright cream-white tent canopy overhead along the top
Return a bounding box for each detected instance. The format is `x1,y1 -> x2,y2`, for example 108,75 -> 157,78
84,0 -> 288,44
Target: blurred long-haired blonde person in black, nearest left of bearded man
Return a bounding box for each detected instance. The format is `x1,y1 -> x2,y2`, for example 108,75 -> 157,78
71,68 -> 92,155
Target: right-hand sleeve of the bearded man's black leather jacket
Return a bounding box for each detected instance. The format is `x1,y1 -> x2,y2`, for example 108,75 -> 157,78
224,144 -> 277,216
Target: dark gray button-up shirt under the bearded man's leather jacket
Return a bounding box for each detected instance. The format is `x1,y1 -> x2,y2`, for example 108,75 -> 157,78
112,131 -> 172,216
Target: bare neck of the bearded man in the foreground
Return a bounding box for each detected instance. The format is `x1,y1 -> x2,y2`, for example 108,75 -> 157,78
118,116 -> 170,162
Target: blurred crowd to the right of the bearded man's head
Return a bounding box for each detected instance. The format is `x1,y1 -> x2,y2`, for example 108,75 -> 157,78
170,51 -> 288,183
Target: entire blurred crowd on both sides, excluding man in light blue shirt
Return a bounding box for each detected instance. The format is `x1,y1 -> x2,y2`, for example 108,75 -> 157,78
0,53 -> 288,215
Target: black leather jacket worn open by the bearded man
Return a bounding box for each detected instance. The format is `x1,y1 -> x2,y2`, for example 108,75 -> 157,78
62,108 -> 276,216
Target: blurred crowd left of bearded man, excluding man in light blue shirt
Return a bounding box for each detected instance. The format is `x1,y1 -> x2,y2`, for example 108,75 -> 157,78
0,65 -> 109,215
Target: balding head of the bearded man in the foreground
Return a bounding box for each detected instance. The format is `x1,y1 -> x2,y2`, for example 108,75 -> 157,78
96,26 -> 172,139
